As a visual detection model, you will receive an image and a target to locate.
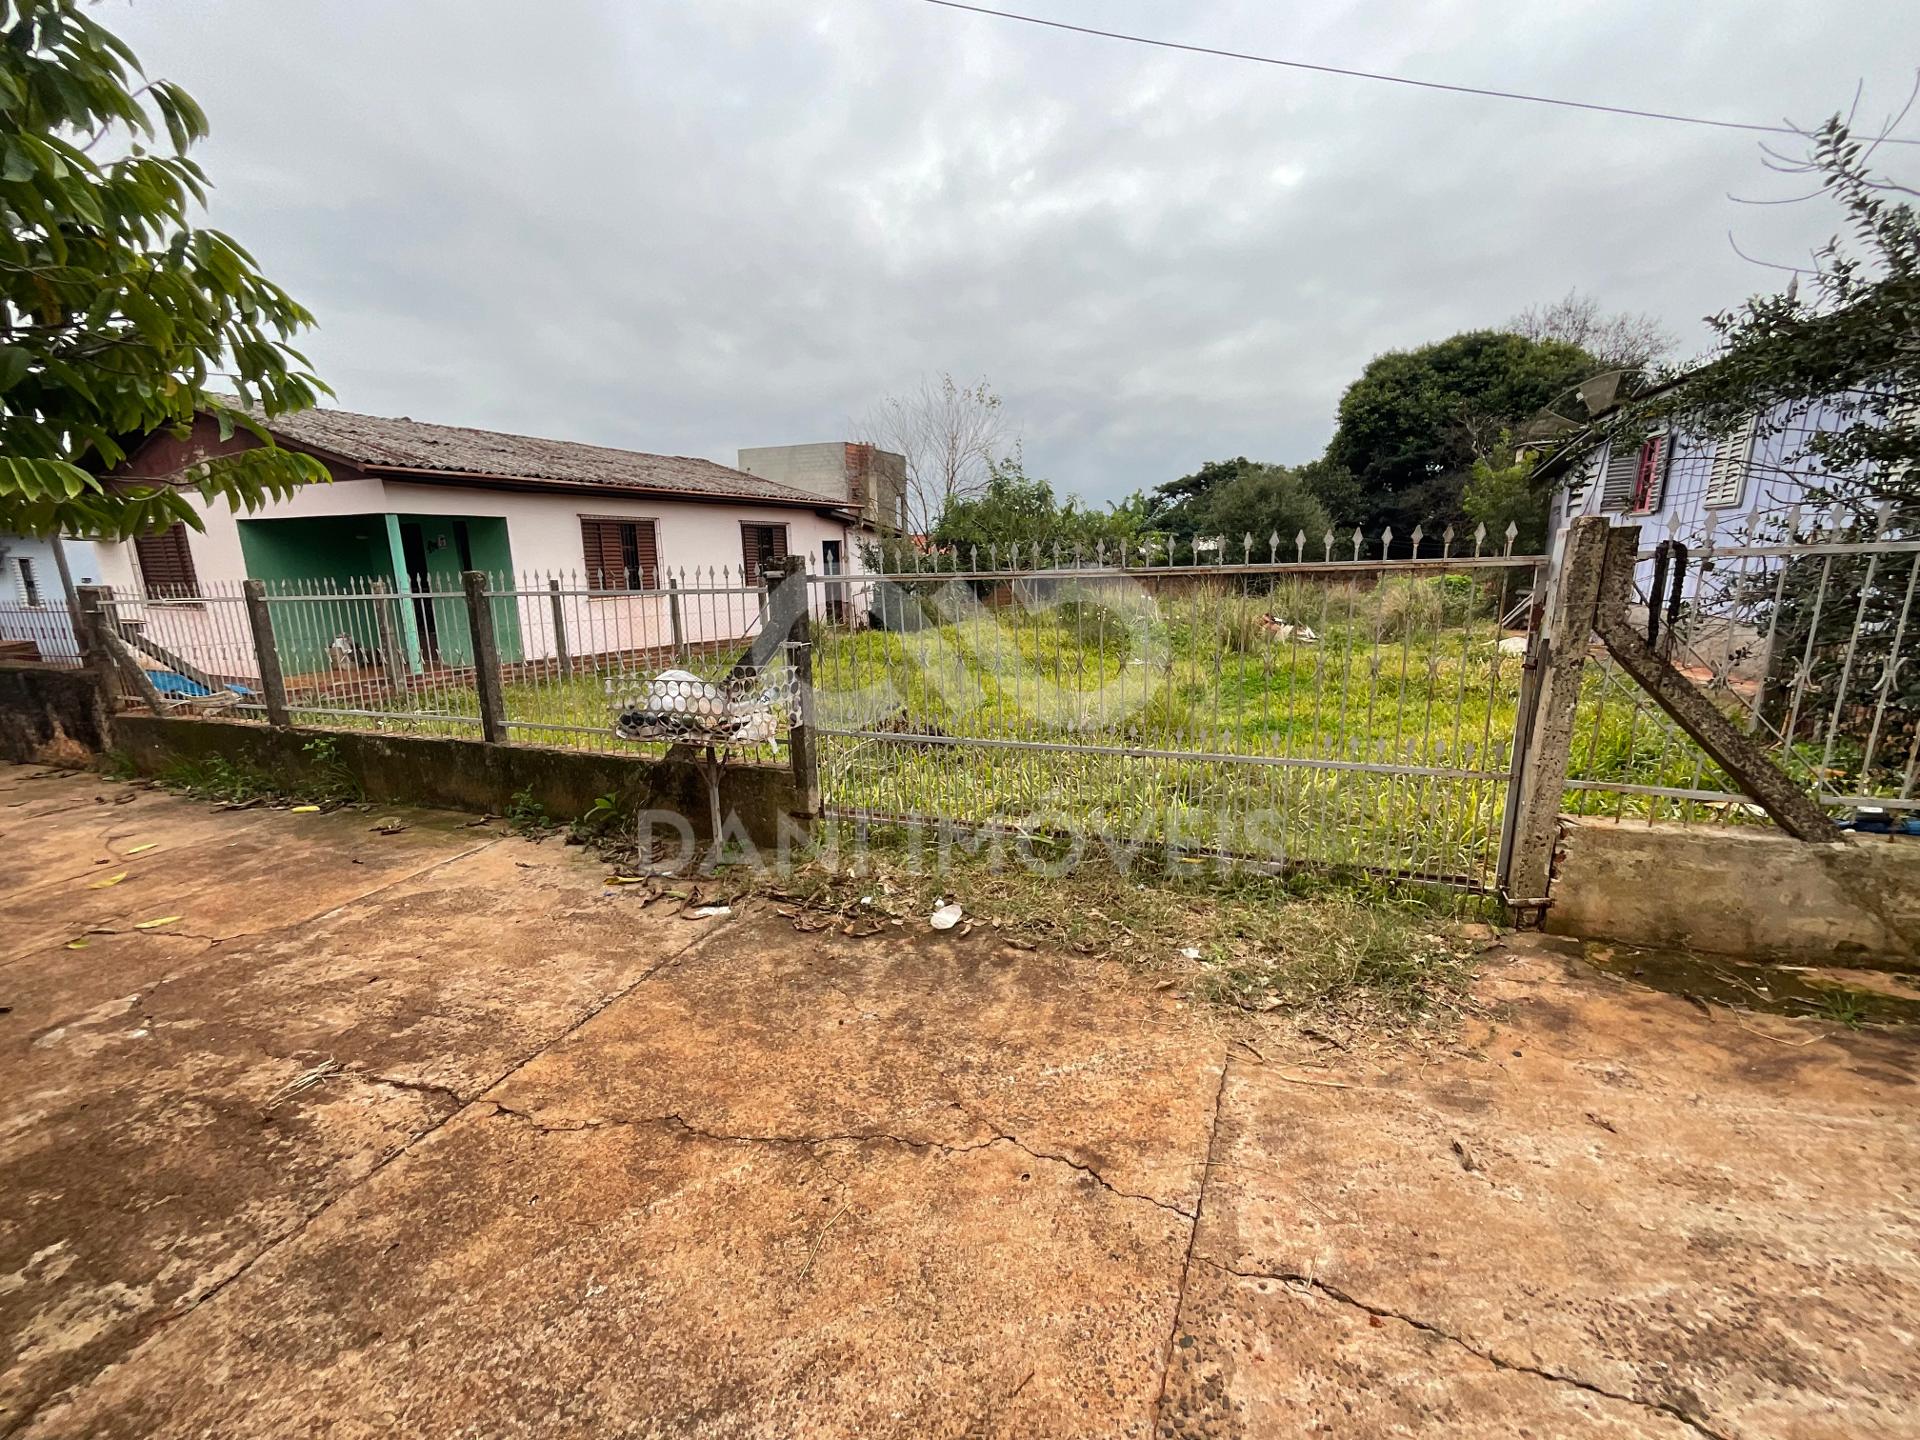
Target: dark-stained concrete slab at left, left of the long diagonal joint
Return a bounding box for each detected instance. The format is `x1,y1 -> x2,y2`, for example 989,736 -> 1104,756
0,794 -> 718,1432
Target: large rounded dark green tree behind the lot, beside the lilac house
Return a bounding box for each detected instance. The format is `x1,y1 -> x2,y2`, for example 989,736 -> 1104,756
1327,330 -> 1599,534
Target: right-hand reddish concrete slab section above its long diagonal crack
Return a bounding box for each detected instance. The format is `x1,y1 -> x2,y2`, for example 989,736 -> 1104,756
1175,948 -> 1920,1440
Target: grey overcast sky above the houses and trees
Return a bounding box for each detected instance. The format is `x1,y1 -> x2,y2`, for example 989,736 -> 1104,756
112,0 -> 1920,499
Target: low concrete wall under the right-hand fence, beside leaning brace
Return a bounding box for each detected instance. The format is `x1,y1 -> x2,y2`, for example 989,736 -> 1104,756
1546,816 -> 1920,970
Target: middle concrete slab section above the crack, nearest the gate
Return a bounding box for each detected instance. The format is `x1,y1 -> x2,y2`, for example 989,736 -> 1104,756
490,910 -> 1223,1212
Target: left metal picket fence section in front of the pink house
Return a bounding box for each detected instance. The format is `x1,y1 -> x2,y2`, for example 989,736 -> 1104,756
90,568 -> 787,755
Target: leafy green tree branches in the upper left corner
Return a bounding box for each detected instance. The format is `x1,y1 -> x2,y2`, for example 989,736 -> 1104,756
0,0 -> 326,536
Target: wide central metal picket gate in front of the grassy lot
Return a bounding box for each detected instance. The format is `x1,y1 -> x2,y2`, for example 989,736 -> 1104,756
808,530 -> 1540,891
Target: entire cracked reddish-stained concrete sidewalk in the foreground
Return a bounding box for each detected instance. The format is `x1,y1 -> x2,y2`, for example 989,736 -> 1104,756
0,768 -> 1920,1438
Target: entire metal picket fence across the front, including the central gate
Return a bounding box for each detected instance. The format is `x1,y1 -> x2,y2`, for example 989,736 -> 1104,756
63,515 -> 1920,891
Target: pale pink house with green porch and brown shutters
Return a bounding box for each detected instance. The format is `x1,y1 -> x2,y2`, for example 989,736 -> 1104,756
37,409 -> 897,676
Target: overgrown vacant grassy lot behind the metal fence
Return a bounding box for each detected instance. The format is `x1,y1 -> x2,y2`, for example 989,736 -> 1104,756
270,568 -> 1781,885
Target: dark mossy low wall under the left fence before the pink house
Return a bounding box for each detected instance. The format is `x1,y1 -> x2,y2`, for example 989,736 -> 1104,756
113,714 -> 801,845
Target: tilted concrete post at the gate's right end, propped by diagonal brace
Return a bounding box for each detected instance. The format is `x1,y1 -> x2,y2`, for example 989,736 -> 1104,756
1507,515 -> 1607,906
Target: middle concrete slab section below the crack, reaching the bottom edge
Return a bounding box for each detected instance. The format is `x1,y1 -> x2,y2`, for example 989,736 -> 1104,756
33,1106 -> 1187,1440
